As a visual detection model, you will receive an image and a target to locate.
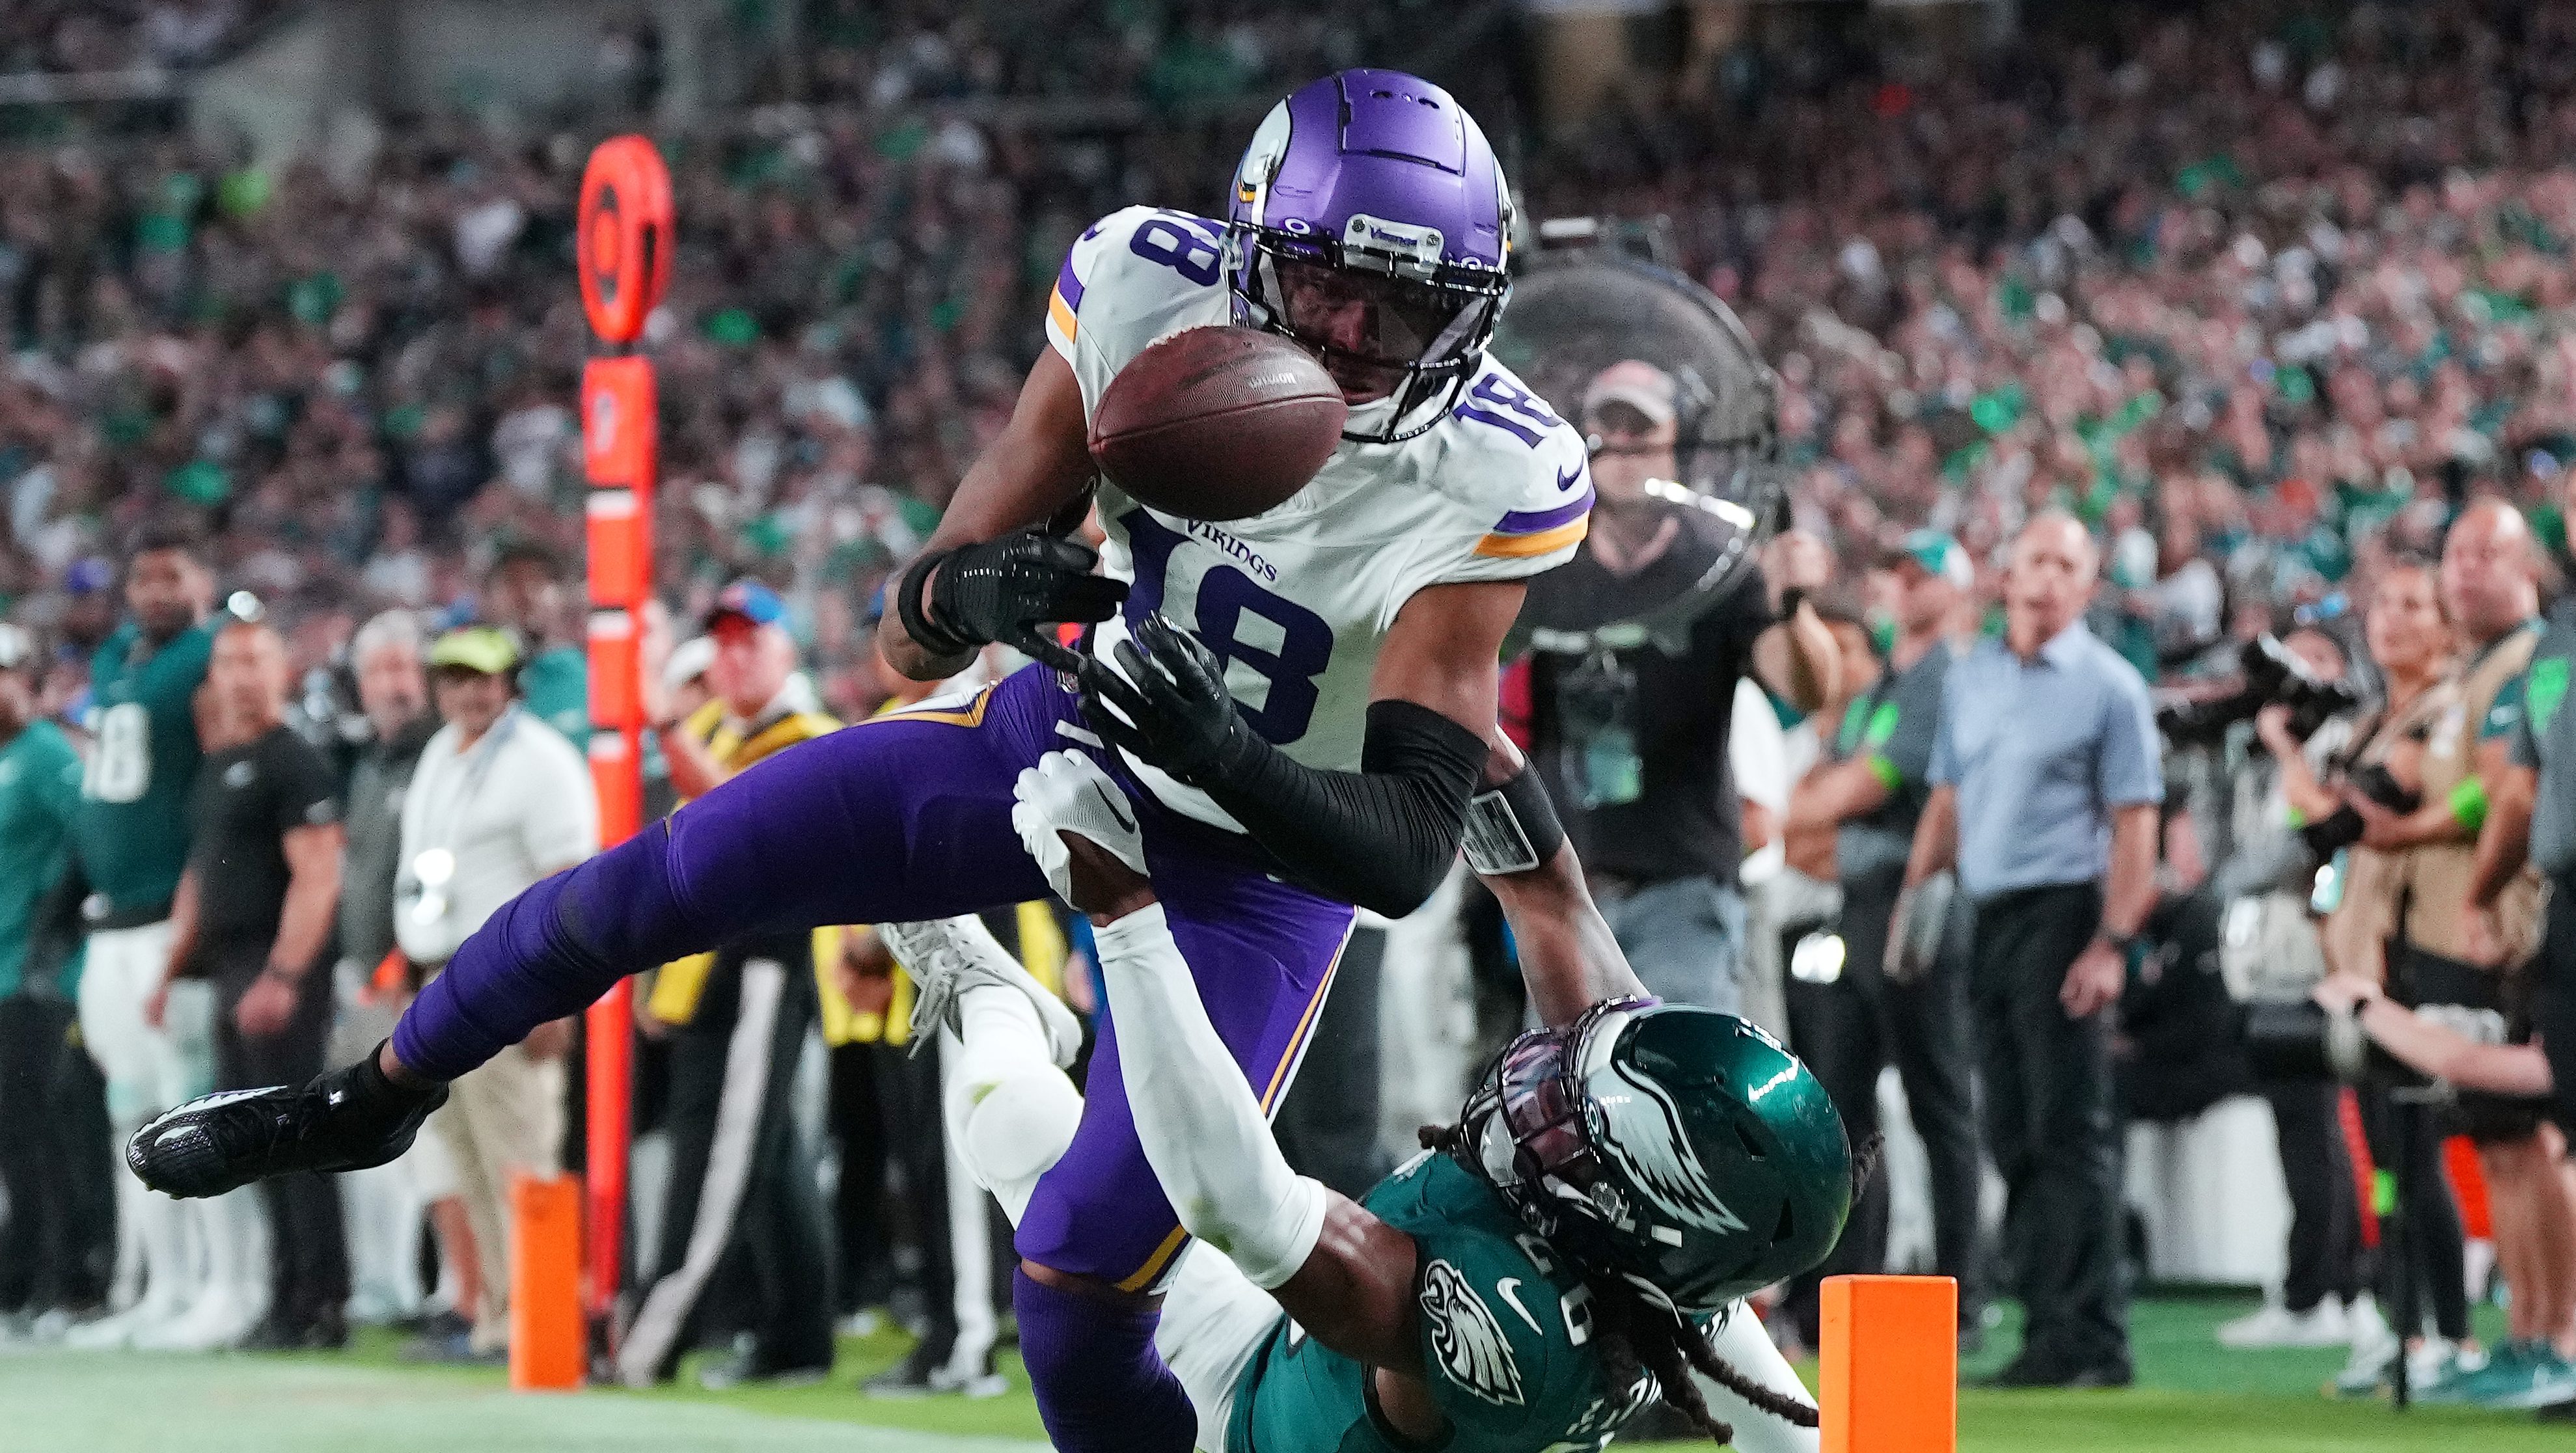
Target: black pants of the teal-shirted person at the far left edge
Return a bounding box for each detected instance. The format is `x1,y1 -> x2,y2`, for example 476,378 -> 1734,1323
0,994 -> 116,1311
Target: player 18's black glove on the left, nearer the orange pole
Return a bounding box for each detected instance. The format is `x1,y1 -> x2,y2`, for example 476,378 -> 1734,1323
896,531 -> 1129,667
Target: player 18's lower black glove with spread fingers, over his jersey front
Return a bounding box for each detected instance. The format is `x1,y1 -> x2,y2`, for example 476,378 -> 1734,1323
1079,610 -> 1262,786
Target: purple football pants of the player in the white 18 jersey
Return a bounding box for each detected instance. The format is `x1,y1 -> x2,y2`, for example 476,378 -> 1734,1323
394,667 -> 1355,1291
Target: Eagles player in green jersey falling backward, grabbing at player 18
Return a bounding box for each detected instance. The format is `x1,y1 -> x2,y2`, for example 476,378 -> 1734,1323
884,752 -> 1855,1453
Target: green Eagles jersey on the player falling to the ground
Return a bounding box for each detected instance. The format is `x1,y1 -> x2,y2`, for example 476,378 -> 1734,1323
1226,1154 -> 1654,1453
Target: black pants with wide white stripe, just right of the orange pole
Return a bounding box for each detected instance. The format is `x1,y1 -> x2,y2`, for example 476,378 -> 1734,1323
631,935 -> 832,1373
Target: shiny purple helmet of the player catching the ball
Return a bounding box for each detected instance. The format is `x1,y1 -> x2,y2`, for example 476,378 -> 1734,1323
1226,70 -> 1512,443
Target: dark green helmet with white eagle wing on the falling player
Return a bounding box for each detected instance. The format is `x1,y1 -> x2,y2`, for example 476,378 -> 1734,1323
1460,999 -> 1852,1311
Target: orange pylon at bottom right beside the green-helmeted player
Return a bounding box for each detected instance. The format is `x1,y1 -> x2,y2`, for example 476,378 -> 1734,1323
1816,1275 -> 1958,1453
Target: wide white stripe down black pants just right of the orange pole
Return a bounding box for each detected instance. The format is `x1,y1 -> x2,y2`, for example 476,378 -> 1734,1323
618,958 -> 788,1389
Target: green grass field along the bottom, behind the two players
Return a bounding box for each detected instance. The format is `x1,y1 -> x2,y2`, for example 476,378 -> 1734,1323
0,1301 -> 2571,1453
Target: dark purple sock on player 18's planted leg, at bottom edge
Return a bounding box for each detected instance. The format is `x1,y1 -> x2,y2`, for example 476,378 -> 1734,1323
1010,1268 -> 1198,1453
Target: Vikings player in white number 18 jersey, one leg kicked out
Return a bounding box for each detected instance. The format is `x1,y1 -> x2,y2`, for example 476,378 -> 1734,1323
129,70 -> 1638,1453
